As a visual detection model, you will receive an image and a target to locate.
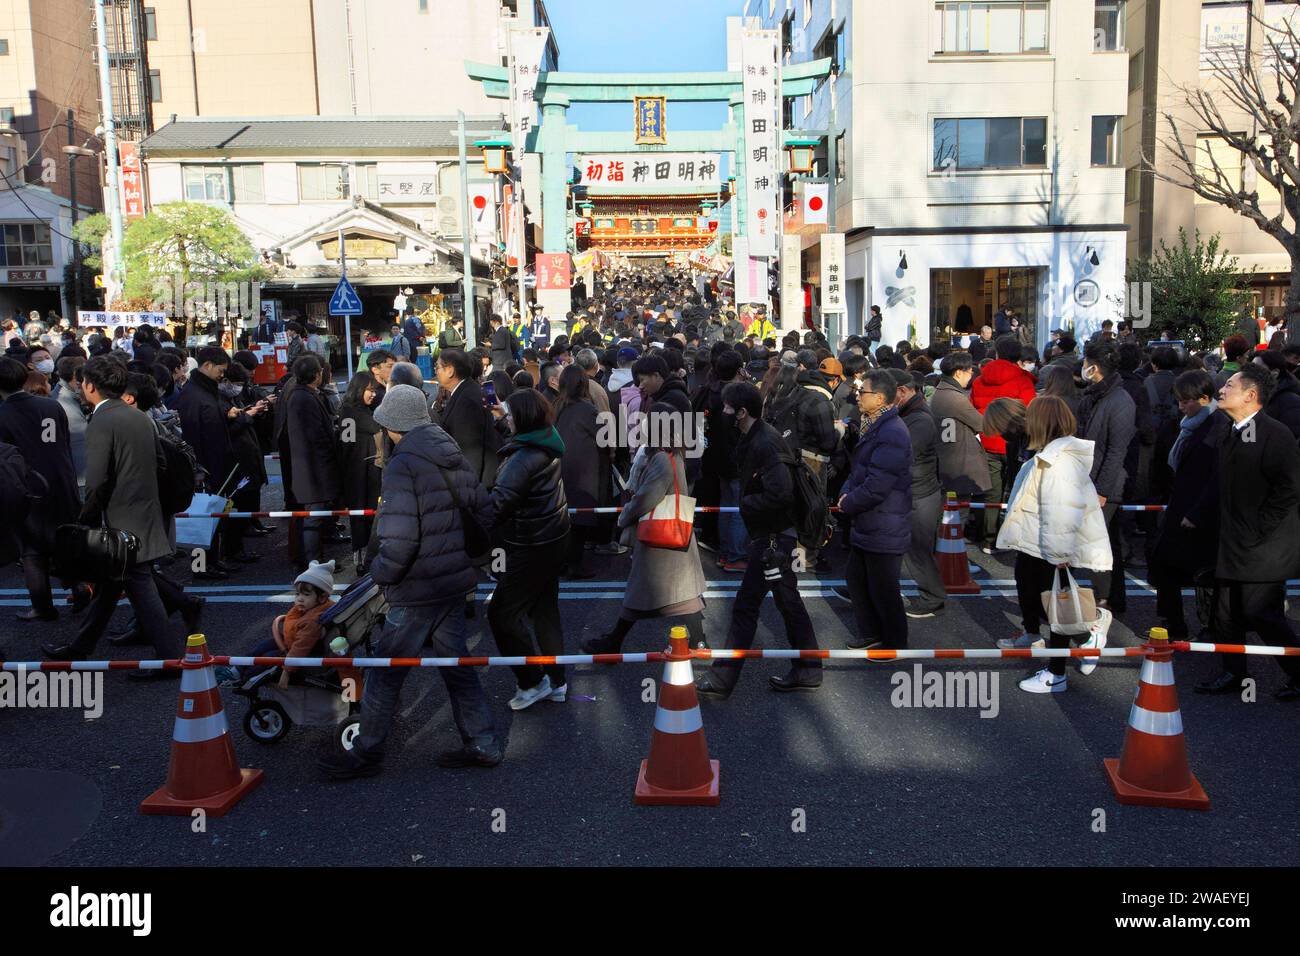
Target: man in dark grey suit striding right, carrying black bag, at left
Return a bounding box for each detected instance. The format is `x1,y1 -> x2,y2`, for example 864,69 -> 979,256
42,355 -> 181,680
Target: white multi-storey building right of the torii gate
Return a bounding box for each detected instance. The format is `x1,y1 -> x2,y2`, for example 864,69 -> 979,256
742,0 -> 1128,347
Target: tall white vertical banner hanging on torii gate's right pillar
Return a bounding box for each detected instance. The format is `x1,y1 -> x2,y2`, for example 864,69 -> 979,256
741,30 -> 781,256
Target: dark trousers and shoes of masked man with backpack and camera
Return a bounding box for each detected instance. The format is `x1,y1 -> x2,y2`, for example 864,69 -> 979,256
712,535 -> 822,687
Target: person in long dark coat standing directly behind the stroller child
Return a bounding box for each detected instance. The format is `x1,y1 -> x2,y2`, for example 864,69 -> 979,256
285,355 -> 342,571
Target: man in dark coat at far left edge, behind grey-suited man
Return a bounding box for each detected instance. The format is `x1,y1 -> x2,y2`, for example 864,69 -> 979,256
0,358 -> 90,620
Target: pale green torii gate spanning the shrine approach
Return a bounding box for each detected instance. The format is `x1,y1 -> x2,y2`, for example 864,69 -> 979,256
465,57 -> 831,311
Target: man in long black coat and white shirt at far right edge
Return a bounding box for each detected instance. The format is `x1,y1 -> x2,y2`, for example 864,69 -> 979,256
1196,364 -> 1300,701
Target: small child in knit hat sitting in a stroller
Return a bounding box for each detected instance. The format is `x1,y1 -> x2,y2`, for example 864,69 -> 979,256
230,562 -> 386,748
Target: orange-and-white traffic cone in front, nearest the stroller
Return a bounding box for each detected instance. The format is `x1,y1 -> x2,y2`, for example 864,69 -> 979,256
140,633 -> 261,817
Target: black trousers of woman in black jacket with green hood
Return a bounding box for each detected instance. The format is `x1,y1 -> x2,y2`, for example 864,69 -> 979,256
488,538 -> 566,691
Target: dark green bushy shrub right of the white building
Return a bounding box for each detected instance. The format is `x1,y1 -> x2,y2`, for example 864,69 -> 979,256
1128,229 -> 1251,350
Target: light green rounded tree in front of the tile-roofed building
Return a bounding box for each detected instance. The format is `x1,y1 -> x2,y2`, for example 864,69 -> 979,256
122,203 -> 268,337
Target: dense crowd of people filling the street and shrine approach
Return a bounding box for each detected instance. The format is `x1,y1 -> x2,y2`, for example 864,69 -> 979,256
0,268 -> 1300,779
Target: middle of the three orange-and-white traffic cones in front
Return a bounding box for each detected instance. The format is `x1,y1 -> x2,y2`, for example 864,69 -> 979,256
633,627 -> 719,806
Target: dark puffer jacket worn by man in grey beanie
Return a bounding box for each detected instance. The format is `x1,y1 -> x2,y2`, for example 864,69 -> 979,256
371,424 -> 491,607
